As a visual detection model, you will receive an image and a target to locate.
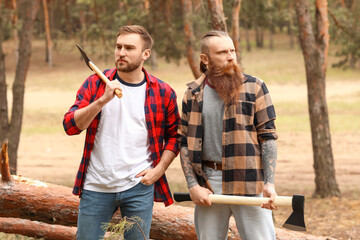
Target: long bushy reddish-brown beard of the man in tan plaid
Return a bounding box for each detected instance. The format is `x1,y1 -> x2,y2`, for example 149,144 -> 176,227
206,61 -> 244,104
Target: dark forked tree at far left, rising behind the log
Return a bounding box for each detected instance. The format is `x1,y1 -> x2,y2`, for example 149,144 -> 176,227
0,0 -> 39,174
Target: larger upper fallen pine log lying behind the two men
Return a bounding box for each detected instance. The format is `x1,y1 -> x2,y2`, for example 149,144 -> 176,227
0,175 -> 330,240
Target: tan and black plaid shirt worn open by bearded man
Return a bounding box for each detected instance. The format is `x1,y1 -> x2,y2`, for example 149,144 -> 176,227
178,75 -> 277,196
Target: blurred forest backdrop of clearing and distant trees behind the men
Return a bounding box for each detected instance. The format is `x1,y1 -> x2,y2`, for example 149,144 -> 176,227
0,0 -> 360,239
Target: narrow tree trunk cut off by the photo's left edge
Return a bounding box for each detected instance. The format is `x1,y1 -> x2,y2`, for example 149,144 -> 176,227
0,0 -> 9,143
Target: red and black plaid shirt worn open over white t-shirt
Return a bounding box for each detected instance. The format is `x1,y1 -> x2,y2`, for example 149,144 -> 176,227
63,68 -> 180,206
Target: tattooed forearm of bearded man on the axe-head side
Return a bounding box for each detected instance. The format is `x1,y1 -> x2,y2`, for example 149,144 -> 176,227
261,140 -> 277,184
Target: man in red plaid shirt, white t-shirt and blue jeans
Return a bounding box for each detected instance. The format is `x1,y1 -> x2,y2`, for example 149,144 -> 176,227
63,25 -> 180,240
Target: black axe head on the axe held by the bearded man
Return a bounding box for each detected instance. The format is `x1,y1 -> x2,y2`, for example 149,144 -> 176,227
283,195 -> 306,231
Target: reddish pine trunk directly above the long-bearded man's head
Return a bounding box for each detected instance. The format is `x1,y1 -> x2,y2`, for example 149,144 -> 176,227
208,0 -> 227,32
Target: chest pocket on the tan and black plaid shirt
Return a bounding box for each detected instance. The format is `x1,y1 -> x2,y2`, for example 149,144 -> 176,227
235,100 -> 255,127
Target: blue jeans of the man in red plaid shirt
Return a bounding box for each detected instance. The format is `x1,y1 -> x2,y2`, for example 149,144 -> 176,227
76,182 -> 154,240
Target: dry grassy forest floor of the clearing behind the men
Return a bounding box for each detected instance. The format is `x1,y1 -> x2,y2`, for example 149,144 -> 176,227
0,36 -> 360,240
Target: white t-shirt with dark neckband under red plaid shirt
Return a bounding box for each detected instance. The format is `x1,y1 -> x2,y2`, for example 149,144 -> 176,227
84,76 -> 152,193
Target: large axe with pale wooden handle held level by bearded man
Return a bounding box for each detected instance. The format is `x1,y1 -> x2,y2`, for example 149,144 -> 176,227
174,193 -> 306,231
